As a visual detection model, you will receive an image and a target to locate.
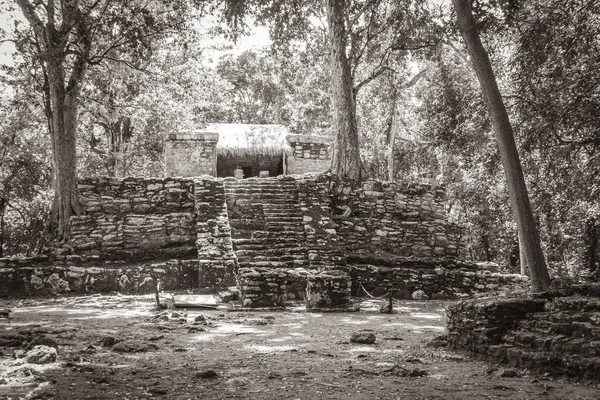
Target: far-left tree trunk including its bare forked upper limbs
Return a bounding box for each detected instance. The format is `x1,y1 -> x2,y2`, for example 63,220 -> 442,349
15,0 -> 93,239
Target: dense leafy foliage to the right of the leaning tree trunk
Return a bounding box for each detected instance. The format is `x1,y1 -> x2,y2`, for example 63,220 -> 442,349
511,0 -> 600,272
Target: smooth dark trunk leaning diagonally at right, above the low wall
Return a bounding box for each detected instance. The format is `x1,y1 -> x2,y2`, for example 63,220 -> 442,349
452,0 -> 550,292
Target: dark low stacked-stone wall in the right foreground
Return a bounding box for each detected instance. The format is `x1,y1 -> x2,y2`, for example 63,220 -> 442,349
447,284 -> 600,382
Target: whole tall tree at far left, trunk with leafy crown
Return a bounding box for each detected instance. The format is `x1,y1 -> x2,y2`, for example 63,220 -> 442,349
15,0 -> 199,238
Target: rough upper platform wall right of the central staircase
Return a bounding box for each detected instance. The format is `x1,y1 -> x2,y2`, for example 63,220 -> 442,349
331,181 -> 465,258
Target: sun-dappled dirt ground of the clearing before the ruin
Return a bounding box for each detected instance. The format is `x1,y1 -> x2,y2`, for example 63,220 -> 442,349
0,294 -> 600,400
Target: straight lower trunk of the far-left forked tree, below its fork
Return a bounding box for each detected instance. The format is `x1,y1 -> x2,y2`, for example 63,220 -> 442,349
47,59 -> 80,239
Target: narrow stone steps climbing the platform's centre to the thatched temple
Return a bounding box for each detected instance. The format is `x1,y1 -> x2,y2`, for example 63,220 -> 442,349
224,178 -> 307,268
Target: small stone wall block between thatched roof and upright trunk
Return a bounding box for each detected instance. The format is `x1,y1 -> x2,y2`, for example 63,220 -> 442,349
286,135 -> 333,175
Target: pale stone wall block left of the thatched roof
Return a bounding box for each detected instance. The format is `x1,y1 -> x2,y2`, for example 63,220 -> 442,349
164,132 -> 219,176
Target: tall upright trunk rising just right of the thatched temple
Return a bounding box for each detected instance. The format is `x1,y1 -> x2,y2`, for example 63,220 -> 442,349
327,0 -> 362,181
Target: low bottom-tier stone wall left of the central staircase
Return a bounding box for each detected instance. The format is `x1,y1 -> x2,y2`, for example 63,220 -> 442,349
0,256 -> 198,298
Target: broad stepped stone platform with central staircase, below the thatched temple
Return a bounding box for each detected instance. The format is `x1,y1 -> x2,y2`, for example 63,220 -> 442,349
0,174 -> 524,307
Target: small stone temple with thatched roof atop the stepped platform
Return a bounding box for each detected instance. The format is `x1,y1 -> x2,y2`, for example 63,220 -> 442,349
164,124 -> 333,178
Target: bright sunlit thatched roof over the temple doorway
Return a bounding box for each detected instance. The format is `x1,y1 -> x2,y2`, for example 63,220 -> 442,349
204,124 -> 292,157
